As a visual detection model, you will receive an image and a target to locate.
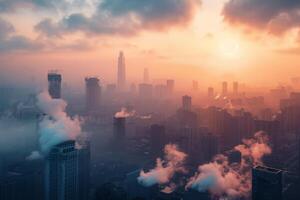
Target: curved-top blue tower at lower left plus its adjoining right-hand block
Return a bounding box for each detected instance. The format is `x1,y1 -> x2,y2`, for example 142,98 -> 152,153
45,140 -> 90,200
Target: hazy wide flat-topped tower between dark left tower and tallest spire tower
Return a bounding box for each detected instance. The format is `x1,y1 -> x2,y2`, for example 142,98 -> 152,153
85,77 -> 101,112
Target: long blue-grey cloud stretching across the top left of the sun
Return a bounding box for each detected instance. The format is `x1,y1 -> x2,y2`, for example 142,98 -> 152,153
35,0 -> 201,37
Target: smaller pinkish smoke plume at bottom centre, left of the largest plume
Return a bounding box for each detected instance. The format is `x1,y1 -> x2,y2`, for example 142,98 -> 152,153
138,144 -> 187,193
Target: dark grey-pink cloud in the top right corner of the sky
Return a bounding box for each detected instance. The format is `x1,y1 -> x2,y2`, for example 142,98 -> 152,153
223,0 -> 300,35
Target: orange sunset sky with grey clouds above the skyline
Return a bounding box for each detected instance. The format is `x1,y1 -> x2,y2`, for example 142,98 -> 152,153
0,0 -> 300,89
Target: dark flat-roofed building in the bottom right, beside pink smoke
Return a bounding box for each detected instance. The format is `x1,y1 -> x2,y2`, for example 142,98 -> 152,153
252,166 -> 283,200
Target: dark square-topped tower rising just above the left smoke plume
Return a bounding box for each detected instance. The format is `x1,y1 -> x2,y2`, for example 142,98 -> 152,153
48,71 -> 62,99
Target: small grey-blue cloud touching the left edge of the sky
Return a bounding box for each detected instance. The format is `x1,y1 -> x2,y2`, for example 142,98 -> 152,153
0,18 -> 43,52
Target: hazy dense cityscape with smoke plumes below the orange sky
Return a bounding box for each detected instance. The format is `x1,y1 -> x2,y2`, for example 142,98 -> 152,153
0,52 -> 300,200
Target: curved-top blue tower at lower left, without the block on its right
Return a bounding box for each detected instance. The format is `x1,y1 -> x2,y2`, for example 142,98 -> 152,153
45,141 -> 78,200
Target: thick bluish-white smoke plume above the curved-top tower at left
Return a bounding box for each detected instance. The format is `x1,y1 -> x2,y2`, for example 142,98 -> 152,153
37,92 -> 82,154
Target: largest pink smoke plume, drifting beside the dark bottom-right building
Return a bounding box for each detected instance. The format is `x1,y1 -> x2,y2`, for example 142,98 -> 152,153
186,132 -> 272,199
